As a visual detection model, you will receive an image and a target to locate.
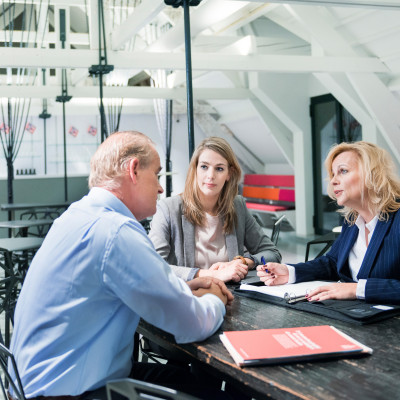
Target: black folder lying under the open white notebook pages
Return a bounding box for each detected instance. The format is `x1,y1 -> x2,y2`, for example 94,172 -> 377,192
234,287 -> 400,325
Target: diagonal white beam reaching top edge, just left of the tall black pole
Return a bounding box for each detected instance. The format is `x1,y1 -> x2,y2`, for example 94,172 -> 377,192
111,0 -> 166,50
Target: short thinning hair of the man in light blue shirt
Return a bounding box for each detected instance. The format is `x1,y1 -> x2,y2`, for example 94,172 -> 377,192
89,131 -> 153,190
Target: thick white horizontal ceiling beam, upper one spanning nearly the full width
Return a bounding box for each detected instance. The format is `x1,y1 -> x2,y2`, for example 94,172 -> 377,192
0,47 -> 393,73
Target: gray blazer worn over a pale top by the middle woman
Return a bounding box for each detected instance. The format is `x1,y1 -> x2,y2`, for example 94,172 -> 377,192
149,195 -> 282,281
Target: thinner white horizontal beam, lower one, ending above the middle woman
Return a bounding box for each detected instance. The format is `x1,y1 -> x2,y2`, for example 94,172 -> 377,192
0,85 -> 254,100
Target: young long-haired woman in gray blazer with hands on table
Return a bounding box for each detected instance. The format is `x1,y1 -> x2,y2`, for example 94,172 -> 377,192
149,137 -> 281,282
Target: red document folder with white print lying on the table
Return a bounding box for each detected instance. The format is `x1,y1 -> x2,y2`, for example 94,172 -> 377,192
220,325 -> 372,366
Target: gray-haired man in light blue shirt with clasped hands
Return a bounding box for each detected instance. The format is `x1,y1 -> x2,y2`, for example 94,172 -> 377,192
11,132 -> 233,399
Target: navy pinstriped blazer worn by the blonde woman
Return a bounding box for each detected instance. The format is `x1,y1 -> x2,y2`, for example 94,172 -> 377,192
294,211 -> 400,304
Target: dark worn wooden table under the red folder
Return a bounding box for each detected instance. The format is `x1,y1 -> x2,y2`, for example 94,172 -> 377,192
138,290 -> 400,400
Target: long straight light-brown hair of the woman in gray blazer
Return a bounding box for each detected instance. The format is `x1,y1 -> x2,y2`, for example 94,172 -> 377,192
182,136 -> 242,233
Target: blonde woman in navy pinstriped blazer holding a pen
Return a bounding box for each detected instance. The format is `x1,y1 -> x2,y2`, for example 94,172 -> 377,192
257,141 -> 400,304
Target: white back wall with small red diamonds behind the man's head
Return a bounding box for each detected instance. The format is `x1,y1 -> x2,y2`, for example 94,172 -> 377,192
0,114 -> 208,198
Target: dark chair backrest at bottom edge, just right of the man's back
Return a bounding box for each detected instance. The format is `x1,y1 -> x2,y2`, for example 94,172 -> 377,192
107,378 -> 197,400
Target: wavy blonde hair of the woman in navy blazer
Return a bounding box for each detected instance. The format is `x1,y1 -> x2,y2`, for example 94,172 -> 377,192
325,141 -> 400,224
